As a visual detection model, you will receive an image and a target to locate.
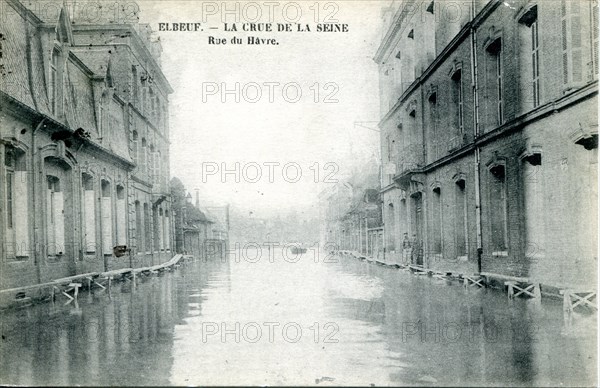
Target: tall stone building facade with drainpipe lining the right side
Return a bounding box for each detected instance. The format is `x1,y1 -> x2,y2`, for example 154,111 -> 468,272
374,0 -> 598,292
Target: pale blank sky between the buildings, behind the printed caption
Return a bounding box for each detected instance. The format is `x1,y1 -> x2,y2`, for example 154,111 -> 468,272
139,0 -> 385,217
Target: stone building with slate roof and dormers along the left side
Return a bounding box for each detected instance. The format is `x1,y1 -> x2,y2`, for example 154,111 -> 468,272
0,0 -> 173,288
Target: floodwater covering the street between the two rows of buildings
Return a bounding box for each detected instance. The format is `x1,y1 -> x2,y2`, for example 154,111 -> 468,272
0,251 -> 597,386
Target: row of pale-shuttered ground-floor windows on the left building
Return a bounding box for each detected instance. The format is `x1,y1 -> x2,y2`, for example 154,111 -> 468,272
4,146 -> 171,259
